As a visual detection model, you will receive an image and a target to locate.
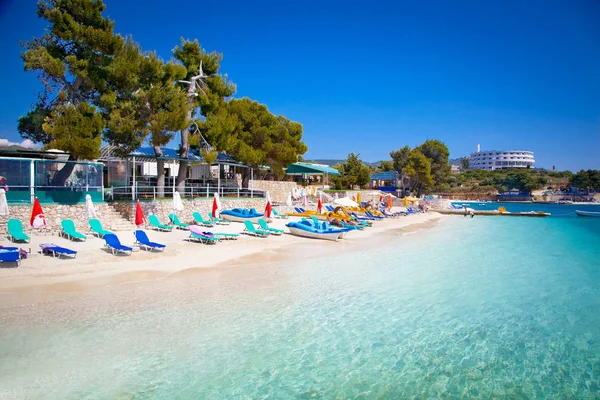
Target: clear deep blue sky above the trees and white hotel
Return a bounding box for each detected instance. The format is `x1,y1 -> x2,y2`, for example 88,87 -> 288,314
0,0 -> 600,170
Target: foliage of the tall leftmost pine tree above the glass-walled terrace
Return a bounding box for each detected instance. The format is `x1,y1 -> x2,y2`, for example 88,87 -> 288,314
18,0 -> 123,159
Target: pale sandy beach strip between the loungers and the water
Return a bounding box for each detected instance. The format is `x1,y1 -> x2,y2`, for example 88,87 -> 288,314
0,213 -> 443,307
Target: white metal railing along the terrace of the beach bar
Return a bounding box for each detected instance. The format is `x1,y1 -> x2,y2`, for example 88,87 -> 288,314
104,185 -> 265,201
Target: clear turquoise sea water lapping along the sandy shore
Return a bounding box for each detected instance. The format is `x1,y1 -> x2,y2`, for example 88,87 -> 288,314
0,211 -> 600,399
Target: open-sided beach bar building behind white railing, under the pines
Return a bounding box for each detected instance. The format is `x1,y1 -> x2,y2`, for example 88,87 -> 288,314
99,145 -> 264,200
